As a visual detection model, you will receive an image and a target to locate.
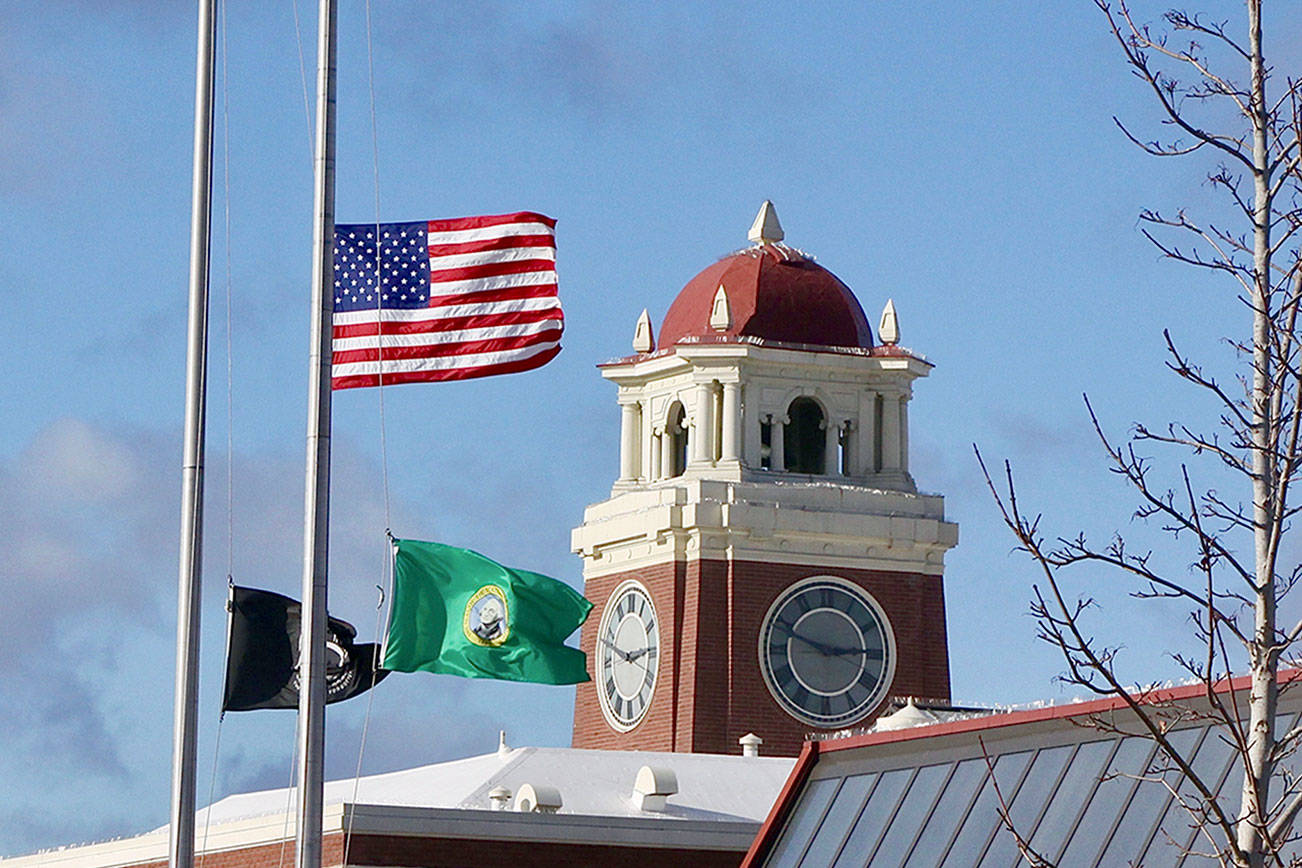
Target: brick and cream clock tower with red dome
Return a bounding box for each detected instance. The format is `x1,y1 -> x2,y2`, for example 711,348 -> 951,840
573,202 -> 958,755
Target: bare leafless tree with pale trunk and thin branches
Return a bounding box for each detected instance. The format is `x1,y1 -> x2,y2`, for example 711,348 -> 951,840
982,0 -> 1302,868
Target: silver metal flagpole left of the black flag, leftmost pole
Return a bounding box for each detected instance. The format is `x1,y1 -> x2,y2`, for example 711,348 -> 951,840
168,0 -> 216,868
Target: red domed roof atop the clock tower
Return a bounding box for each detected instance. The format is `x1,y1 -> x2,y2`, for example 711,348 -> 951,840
656,243 -> 872,349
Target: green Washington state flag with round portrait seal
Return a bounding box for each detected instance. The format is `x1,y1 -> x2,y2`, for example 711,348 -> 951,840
383,540 -> 592,685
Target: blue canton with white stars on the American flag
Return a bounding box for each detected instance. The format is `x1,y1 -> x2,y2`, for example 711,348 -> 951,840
335,220 -> 430,314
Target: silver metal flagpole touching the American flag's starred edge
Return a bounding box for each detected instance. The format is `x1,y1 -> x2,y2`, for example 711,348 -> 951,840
296,0 -> 336,868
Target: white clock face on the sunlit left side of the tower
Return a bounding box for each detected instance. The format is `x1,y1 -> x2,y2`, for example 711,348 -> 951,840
596,580 -> 660,731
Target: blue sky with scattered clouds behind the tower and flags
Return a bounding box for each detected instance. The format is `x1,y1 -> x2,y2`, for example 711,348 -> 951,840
0,0 -> 1302,854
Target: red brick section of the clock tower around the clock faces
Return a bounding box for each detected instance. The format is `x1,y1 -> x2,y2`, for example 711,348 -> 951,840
573,560 -> 949,756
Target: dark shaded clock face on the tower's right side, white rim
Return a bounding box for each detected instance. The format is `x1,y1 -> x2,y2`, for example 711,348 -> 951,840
759,576 -> 896,727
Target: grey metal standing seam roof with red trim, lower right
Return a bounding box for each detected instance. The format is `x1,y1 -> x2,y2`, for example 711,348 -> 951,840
743,685 -> 1302,868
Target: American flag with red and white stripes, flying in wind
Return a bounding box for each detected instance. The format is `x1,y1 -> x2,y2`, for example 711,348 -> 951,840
331,211 -> 565,389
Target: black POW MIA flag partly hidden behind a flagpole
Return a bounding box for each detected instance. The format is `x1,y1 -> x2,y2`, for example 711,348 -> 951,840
221,586 -> 389,712
